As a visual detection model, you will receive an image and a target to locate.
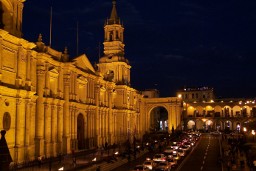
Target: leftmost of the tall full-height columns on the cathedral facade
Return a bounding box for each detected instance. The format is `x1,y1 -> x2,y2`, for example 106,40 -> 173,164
35,65 -> 45,157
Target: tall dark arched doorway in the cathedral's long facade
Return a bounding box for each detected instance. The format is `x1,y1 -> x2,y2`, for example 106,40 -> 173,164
77,113 -> 85,150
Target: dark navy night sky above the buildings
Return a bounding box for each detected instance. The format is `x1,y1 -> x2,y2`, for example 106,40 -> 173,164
23,0 -> 256,98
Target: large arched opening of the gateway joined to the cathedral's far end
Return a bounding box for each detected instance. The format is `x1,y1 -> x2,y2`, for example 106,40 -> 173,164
150,107 -> 168,132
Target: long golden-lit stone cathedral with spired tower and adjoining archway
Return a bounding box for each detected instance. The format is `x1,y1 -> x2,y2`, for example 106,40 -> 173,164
0,0 -> 181,166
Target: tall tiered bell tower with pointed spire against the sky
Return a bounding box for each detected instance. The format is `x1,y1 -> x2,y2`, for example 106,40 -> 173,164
98,0 -> 131,86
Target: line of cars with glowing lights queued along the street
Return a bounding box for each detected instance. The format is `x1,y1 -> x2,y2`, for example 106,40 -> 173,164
133,132 -> 201,171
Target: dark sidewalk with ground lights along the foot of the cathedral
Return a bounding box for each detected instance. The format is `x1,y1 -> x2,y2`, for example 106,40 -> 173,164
15,146 -> 148,171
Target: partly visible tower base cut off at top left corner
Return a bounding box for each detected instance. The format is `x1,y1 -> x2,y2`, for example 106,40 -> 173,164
0,0 -> 25,37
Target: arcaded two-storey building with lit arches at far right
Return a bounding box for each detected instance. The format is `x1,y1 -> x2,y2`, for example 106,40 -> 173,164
177,87 -> 256,131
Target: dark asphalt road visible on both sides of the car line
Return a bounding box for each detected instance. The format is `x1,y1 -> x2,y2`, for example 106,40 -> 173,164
112,134 -> 222,171
